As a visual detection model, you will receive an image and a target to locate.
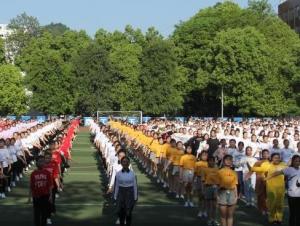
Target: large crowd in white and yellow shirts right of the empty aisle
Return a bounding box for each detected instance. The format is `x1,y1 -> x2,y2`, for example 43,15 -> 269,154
91,119 -> 300,226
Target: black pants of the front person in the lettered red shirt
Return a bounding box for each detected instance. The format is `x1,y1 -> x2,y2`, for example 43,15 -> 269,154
33,195 -> 50,226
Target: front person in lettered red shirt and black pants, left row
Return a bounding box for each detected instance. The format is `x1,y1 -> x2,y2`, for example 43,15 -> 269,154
29,159 -> 53,226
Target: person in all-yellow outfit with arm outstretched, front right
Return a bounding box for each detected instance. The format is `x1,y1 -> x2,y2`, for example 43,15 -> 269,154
248,153 -> 287,224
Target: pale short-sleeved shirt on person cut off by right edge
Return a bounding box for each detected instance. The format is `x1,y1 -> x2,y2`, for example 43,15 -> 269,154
283,167 -> 300,197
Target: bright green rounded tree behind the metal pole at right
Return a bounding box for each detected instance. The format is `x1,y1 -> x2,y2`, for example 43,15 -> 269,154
202,27 -> 289,116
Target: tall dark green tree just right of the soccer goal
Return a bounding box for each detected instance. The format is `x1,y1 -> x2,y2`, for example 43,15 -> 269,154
140,38 -> 183,115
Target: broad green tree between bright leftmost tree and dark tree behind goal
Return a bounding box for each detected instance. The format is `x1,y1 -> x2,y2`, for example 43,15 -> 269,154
16,31 -> 90,114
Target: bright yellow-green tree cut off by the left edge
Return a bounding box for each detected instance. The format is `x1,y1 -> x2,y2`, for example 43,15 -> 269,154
0,65 -> 26,116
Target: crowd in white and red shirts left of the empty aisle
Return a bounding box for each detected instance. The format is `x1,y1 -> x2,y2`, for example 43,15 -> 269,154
0,119 -> 79,226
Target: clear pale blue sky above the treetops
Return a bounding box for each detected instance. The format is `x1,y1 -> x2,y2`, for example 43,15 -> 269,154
0,0 -> 280,36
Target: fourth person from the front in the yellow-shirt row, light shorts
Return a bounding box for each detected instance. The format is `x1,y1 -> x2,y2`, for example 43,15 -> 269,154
179,146 -> 196,207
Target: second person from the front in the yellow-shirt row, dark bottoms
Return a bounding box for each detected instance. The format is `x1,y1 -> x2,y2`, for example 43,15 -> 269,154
202,156 -> 219,226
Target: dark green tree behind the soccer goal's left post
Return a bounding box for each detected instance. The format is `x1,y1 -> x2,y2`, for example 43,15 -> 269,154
73,43 -> 115,115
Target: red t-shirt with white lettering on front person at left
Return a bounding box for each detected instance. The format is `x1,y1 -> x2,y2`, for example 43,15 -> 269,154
30,169 -> 53,198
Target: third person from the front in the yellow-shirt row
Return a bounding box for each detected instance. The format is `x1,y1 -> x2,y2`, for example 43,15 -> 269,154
195,151 -> 208,217
